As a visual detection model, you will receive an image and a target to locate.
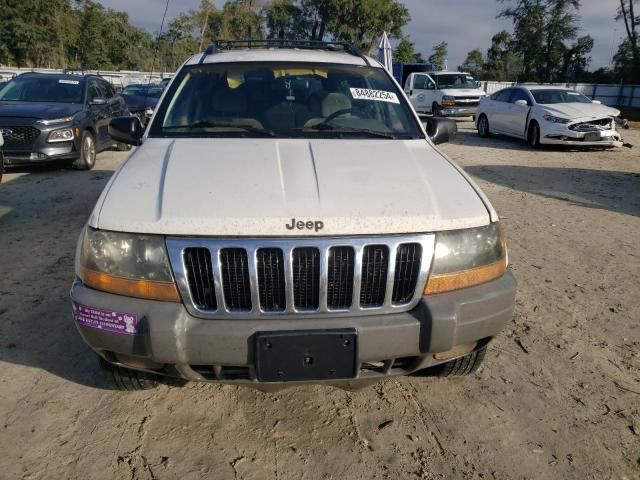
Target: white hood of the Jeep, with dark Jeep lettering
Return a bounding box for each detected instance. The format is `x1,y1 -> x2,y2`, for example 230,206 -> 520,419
89,138 -> 490,236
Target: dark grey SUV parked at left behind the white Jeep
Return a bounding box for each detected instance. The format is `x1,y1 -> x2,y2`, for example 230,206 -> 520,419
0,73 -> 130,169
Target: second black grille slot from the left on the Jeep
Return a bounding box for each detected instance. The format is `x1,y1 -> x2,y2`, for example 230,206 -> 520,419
220,248 -> 252,312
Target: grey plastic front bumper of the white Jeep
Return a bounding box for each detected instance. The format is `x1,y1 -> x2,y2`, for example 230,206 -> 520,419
71,272 -> 516,386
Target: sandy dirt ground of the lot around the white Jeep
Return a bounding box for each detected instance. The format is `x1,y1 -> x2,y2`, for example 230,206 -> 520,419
0,122 -> 640,480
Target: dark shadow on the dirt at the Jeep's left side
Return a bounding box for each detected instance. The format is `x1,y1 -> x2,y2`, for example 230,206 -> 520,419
0,166 -> 113,388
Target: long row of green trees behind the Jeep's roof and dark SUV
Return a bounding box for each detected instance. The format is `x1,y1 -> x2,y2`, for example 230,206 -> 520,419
0,0 -> 410,71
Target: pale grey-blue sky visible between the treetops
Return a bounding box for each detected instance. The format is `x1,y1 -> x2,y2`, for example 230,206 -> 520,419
100,0 -> 625,70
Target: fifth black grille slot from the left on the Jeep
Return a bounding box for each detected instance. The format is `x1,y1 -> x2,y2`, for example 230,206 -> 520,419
327,247 -> 355,310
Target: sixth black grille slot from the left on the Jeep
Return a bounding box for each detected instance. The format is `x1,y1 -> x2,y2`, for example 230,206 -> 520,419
360,245 -> 389,308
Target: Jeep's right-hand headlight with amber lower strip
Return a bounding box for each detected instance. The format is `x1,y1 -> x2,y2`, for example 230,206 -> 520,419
424,223 -> 507,295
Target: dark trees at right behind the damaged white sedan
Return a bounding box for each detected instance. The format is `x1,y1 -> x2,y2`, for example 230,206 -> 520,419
460,0 -> 640,83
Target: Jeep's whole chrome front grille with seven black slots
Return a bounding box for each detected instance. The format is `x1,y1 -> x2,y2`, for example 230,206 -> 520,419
167,235 -> 435,318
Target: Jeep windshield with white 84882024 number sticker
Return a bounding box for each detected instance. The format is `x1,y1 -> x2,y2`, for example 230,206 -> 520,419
150,62 -> 424,139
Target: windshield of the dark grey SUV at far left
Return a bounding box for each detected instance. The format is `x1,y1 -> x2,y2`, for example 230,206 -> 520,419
0,75 -> 84,103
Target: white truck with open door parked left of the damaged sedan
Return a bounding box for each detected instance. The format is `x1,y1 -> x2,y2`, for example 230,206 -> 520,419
404,72 -> 486,117
